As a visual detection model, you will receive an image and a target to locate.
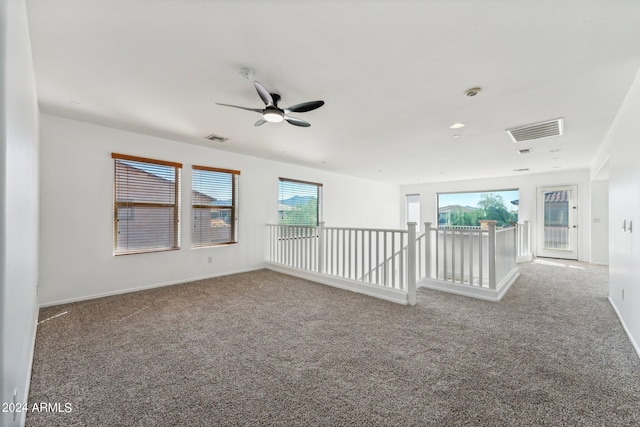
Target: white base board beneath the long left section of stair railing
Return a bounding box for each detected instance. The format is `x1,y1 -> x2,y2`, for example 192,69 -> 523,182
265,262 -> 408,305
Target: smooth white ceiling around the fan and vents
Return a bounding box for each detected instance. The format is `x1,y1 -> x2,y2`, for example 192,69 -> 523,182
27,0 -> 640,184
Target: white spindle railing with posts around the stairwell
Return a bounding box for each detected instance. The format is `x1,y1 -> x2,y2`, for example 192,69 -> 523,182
268,221 -> 530,305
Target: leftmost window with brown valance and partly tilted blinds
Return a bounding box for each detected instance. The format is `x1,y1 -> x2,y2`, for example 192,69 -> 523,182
111,153 -> 182,255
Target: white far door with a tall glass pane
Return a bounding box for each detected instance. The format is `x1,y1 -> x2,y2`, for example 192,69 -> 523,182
536,185 -> 578,259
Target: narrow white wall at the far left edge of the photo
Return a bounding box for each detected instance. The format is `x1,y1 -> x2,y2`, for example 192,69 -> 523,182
0,0 -> 38,426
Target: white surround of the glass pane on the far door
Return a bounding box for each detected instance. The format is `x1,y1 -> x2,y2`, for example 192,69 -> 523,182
536,185 -> 580,260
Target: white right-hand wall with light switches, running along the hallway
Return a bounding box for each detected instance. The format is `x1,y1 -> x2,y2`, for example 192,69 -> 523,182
603,67 -> 640,355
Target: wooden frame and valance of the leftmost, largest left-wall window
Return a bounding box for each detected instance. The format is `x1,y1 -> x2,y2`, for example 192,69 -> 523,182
111,153 -> 182,256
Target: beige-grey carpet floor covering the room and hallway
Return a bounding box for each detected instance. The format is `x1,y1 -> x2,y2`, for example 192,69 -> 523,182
27,260 -> 640,426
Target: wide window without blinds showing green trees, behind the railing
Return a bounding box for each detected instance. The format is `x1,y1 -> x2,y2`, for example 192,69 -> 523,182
438,189 -> 520,228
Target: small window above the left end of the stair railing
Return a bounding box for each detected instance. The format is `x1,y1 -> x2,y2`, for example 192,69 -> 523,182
278,178 -> 322,226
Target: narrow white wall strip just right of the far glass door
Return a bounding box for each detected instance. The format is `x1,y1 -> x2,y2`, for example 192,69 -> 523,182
591,180 -> 609,265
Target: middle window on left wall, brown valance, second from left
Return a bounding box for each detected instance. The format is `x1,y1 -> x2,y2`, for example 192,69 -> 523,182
191,166 -> 240,248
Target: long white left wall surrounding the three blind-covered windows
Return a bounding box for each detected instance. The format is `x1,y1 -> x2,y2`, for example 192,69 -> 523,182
39,115 -> 401,305
